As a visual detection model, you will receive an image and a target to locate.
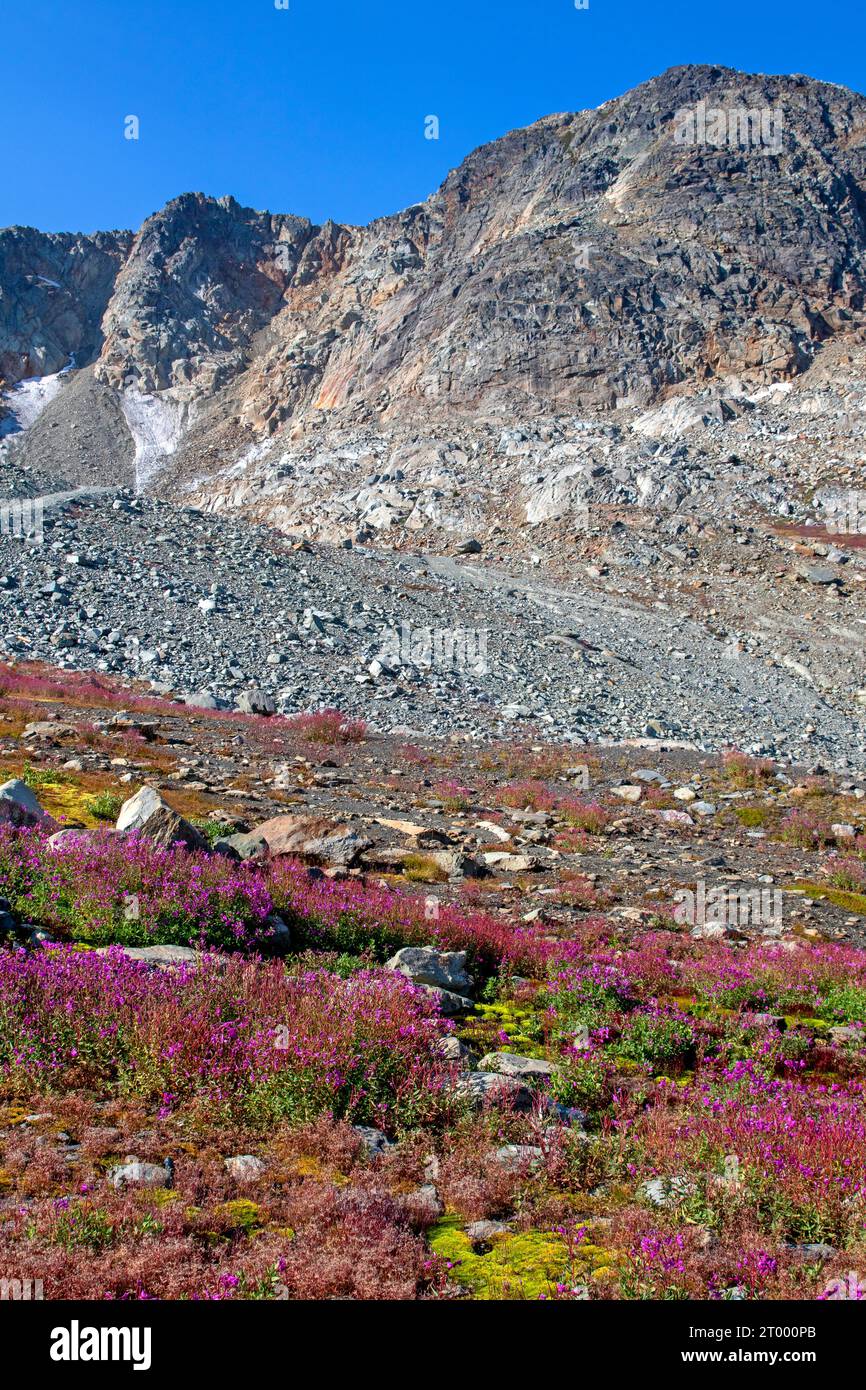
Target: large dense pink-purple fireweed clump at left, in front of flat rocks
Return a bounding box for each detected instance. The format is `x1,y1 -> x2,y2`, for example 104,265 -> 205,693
0,947 -> 450,1129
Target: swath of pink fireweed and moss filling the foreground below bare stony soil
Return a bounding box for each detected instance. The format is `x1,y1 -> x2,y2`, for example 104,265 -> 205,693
0,830 -> 866,1300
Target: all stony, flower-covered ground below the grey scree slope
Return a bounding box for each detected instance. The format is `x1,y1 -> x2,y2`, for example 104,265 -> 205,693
0,664 -> 866,1298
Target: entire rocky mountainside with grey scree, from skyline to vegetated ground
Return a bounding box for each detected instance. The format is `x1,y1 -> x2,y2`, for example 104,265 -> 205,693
0,67 -> 866,769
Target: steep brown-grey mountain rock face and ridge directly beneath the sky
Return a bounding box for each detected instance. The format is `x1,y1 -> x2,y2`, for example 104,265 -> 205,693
0,67 -> 866,497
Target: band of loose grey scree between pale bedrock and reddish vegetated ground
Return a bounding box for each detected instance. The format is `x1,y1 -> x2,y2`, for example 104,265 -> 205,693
0,478 -> 865,771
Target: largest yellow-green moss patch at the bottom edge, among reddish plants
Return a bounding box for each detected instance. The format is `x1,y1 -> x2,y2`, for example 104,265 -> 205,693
430,1216 -> 569,1300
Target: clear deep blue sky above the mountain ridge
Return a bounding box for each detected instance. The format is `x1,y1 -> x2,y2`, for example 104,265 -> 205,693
0,0 -> 866,231
